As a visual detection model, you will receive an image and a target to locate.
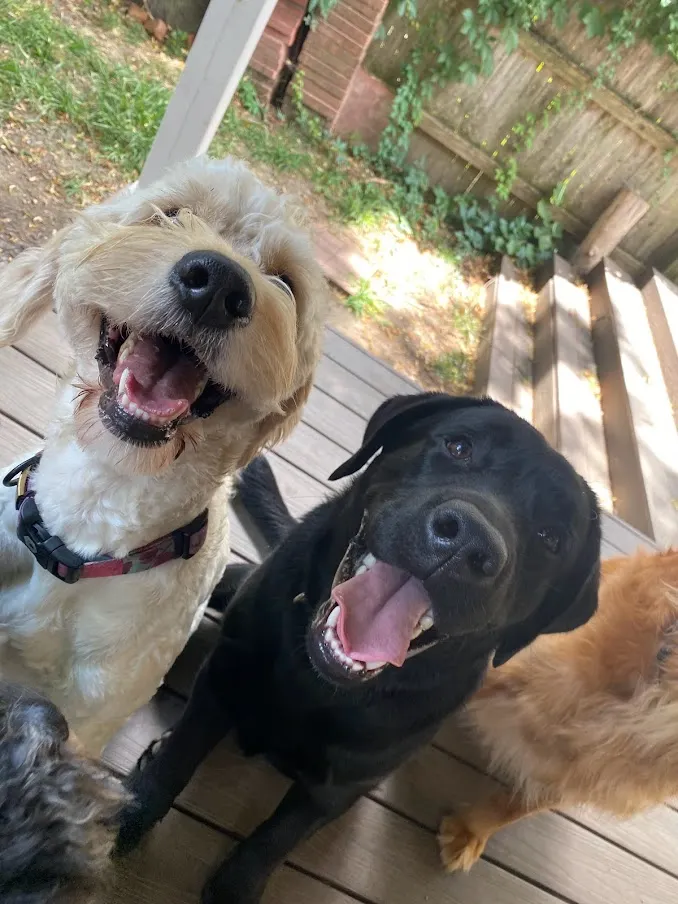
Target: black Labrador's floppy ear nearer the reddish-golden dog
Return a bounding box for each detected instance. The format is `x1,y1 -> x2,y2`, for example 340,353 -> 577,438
492,484 -> 601,667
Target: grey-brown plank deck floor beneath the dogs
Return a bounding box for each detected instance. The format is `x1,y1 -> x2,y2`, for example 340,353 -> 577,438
0,315 -> 678,904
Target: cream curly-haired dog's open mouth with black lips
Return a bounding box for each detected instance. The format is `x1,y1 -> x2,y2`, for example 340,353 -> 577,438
97,317 -> 233,446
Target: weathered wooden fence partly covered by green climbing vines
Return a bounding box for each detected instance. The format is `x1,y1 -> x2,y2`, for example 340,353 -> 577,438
322,0 -> 678,279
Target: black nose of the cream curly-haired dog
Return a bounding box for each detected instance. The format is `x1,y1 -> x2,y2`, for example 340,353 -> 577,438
170,251 -> 254,330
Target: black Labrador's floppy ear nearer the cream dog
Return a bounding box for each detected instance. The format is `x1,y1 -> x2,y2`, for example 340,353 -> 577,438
329,392 -> 499,480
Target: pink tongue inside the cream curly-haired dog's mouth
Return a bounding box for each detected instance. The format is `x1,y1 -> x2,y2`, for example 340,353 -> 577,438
113,336 -> 205,416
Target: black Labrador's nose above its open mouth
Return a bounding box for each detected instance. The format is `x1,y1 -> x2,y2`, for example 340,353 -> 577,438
427,500 -> 508,584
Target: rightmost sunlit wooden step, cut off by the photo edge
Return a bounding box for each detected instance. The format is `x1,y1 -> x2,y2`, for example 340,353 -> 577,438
641,269 -> 678,426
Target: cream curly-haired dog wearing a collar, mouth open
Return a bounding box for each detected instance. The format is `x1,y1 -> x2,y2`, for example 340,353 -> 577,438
0,159 -> 325,754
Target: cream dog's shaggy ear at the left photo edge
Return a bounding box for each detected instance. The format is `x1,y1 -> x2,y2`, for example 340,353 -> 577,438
0,230 -> 65,346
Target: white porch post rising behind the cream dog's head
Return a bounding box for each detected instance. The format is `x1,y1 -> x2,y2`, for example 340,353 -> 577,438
138,0 -> 276,186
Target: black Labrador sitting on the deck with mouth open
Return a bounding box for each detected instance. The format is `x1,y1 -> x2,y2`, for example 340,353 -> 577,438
119,393 -> 600,904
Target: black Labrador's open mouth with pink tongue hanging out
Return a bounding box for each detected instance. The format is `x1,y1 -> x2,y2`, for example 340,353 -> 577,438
308,518 -> 439,680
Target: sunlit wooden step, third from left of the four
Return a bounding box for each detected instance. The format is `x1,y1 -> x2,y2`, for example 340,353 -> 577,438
589,259 -> 678,546
